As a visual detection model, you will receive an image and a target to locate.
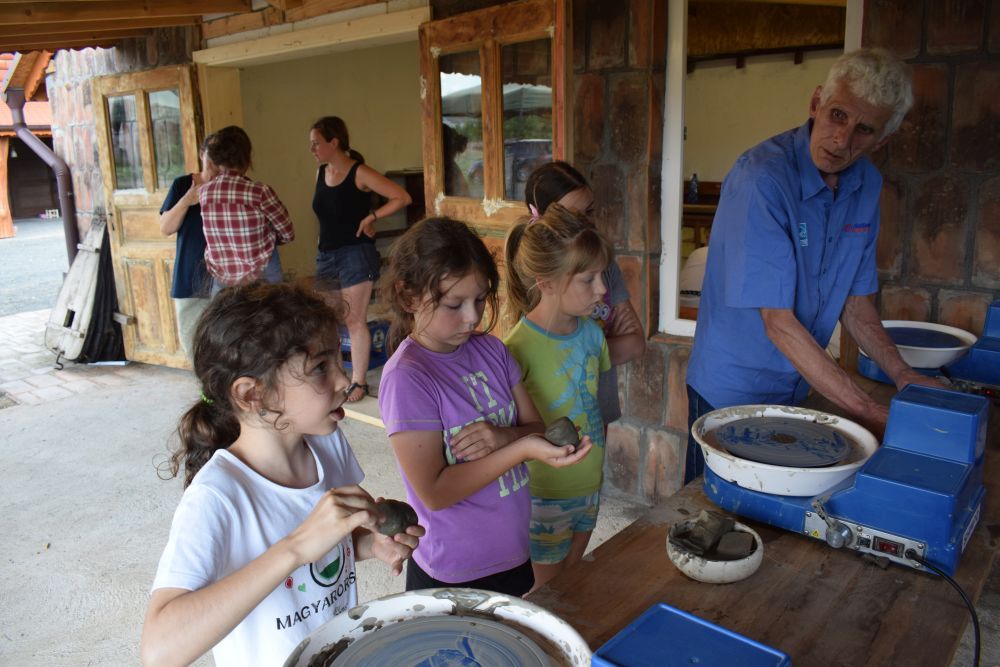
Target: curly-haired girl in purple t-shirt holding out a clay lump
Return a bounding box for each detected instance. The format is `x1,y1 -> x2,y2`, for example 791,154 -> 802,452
378,218 -> 591,595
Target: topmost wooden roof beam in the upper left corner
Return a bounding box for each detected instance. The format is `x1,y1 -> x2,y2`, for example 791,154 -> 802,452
0,0 -> 250,25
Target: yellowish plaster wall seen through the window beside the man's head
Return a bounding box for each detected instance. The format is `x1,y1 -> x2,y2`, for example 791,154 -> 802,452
683,51 -> 841,181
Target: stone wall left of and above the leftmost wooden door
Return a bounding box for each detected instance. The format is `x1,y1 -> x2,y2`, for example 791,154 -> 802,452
45,28 -> 200,243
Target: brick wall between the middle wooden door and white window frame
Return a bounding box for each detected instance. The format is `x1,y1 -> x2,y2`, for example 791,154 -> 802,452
572,0 -> 690,503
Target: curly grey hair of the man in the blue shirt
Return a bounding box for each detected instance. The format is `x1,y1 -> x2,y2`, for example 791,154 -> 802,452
819,49 -> 913,139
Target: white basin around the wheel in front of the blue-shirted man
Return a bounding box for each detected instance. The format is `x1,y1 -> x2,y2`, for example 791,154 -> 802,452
691,405 -> 878,496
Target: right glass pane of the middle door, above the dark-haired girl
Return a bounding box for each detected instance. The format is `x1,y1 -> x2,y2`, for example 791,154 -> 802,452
502,39 -> 552,201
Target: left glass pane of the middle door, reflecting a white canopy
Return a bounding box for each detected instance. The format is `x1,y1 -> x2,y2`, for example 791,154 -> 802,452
438,51 -> 483,199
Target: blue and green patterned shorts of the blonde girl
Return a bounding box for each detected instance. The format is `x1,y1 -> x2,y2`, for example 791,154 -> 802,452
530,491 -> 601,565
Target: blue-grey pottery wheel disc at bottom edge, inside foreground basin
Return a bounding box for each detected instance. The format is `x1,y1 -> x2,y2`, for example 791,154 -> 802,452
326,616 -> 554,667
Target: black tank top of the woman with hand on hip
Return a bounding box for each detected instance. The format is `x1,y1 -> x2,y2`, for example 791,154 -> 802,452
313,162 -> 375,252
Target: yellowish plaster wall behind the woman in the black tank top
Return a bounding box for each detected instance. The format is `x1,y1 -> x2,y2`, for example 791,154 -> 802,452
240,41 -> 421,277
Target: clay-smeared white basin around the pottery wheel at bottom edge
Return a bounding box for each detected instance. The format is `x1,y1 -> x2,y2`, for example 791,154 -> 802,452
284,588 -> 591,667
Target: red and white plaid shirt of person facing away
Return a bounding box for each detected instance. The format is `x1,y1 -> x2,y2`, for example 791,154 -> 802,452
199,169 -> 295,285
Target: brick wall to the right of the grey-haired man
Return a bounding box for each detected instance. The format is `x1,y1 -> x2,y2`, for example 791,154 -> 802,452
863,0 -> 1000,335
